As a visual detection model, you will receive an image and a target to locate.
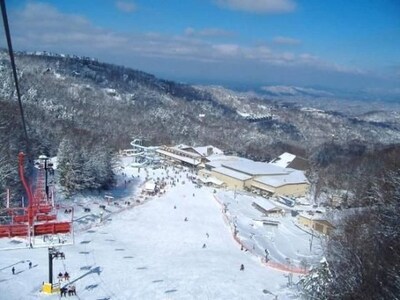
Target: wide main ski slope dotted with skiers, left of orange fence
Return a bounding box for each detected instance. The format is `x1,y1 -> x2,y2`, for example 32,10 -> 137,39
0,158 -> 296,299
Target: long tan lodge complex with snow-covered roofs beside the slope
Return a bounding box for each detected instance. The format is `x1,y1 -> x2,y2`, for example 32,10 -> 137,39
156,145 -> 309,196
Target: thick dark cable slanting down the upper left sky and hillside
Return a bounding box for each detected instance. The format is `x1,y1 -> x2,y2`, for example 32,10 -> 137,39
0,0 -> 30,157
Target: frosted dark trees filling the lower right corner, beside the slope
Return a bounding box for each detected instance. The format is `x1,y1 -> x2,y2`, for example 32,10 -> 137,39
300,168 -> 400,299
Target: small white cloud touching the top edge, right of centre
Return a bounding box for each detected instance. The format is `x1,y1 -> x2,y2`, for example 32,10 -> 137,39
215,0 -> 296,14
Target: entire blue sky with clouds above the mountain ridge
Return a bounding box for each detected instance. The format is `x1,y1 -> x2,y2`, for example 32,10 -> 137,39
0,0 -> 400,96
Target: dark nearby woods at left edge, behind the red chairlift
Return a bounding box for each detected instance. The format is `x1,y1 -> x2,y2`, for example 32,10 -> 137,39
0,101 -> 114,202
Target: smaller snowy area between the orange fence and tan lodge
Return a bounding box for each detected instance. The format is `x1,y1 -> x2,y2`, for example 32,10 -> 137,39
215,190 -> 323,273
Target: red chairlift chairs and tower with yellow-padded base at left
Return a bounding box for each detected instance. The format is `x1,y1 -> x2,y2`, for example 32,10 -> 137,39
0,152 -> 74,294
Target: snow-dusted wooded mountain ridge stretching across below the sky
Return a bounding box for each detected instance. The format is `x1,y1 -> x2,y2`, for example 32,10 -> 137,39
0,52 -> 400,158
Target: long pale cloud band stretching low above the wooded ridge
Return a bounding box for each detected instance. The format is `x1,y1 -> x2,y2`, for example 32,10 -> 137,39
10,2 -> 366,83
